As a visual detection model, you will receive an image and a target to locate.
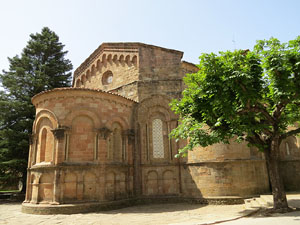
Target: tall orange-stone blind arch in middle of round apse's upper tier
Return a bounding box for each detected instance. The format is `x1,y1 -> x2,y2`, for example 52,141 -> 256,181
68,115 -> 95,162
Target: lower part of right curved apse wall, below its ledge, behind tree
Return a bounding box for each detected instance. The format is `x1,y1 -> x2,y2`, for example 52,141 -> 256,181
182,160 -> 269,198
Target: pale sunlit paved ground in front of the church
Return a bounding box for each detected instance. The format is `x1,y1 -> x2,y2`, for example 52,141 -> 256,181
0,195 -> 300,225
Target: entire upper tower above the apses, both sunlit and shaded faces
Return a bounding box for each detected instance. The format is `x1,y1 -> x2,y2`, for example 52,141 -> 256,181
73,43 -> 192,101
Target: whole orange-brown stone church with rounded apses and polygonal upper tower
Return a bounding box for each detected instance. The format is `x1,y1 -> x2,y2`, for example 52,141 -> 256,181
22,43 -> 300,214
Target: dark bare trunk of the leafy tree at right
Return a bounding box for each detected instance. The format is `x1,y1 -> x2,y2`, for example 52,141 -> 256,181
264,140 -> 289,212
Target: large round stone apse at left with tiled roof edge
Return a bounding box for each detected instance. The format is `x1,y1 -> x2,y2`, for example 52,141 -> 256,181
26,88 -> 135,203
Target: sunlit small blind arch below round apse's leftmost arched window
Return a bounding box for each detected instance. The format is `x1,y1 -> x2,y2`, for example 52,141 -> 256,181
38,173 -> 53,202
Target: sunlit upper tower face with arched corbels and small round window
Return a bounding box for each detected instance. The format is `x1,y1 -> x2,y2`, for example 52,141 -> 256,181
73,43 -> 138,99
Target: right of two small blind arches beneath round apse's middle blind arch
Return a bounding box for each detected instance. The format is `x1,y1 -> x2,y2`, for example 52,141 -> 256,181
83,172 -> 97,200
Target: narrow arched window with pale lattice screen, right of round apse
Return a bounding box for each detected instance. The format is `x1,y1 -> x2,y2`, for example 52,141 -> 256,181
152,119 -> 165,159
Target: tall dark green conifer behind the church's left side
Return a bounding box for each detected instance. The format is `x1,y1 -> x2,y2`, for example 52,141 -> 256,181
0,27 -> 73,190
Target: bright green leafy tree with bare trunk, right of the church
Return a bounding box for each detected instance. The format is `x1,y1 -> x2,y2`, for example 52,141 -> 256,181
171,36 -> 300,211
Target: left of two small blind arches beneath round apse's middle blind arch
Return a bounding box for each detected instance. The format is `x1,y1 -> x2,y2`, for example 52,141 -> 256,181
63,171 -> 77,201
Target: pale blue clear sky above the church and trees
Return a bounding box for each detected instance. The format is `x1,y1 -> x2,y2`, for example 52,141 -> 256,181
0,0 -> 300,71
